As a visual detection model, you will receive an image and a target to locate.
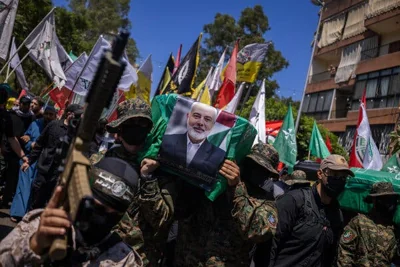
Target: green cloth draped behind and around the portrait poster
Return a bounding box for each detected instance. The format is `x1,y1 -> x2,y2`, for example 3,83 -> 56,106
139,94 -> 257,201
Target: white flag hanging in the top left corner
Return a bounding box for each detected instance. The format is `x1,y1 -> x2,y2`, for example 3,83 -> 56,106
0,0 -> 18,60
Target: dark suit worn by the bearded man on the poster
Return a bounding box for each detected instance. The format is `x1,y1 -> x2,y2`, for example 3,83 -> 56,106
160,133 -> 225,177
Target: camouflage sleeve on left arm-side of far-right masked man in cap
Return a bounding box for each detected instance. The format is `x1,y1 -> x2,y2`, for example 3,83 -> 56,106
337,219 -> 362,267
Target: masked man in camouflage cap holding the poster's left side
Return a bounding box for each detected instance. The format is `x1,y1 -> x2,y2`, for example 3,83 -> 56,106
91,99 -> 174,266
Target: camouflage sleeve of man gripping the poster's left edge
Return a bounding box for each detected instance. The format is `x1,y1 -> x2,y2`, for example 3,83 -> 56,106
138,178 -> 174,235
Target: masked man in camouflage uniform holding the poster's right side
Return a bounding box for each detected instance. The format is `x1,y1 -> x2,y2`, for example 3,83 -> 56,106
232,144 -> 279,266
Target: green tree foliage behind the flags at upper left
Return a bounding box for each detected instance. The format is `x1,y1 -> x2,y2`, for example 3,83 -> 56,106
0,0 -> 138,94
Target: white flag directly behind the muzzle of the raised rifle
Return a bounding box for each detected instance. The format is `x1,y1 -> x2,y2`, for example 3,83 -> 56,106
80,36 -> 138,92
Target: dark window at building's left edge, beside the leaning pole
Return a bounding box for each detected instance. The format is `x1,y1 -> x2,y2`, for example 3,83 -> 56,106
303,90 -> 333,120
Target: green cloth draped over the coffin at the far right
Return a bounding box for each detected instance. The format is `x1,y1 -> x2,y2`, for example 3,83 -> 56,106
338,168 -> 400,225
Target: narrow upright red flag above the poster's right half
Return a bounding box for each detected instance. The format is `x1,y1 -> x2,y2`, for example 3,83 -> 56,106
215,40 -> 239,109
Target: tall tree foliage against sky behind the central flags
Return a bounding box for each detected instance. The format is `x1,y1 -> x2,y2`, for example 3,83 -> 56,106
197,5 -> 289,100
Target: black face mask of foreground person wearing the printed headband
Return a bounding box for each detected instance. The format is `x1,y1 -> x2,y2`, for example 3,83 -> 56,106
79,205 -> 123,245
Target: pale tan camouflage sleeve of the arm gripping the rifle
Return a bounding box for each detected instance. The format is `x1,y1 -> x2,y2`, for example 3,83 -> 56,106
0,210 -> 45,266
